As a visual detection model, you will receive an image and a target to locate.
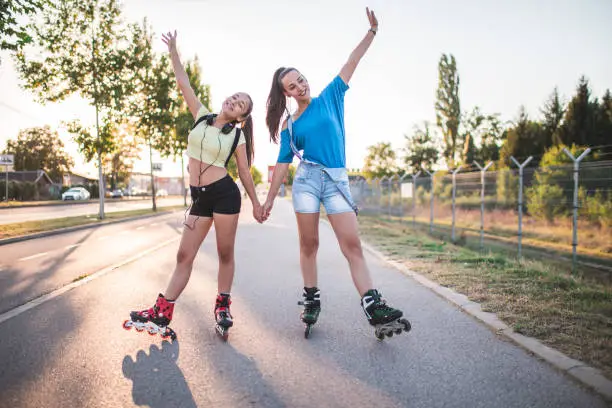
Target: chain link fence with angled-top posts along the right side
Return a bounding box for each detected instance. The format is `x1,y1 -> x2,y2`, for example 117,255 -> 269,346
351,155 -> 612,272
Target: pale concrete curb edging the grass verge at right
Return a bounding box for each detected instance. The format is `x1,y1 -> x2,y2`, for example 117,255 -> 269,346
321,220 -> 612,401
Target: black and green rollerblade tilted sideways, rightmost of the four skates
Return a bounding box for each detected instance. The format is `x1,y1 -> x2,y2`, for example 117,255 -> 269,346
361,289 -> 411,341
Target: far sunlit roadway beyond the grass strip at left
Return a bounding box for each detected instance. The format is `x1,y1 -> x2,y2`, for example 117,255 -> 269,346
0,197 -> 184,225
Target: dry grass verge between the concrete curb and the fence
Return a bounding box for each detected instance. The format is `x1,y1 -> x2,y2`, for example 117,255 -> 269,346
359,215 -> 612,379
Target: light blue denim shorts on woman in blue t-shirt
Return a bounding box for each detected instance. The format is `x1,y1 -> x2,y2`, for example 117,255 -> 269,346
292,162 -> 354,214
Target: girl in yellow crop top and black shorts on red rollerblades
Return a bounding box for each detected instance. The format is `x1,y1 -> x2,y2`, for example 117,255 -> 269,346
124,31 -> 262,339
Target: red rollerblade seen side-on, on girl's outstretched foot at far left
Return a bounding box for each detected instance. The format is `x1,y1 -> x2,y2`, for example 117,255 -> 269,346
123,293 -> 176,340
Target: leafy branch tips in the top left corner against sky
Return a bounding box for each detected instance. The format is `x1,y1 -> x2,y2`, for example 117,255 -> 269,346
0,0 -> 43,63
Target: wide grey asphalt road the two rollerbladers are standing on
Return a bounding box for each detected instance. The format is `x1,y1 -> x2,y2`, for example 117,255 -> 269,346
0,200 -> 606,408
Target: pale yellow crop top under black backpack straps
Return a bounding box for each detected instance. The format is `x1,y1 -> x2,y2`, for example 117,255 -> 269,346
187,105 -> 246,167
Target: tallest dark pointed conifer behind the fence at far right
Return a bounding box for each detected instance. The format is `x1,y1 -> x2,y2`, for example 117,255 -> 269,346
557,76 -> 599,146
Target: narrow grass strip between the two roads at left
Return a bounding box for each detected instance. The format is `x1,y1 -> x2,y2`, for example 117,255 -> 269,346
0,205 -> 184,239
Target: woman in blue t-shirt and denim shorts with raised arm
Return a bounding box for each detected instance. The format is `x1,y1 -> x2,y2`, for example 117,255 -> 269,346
262,9 -> 410,338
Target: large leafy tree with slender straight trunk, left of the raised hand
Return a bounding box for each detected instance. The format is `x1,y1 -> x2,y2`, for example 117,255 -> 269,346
16,0 -> 130,218
